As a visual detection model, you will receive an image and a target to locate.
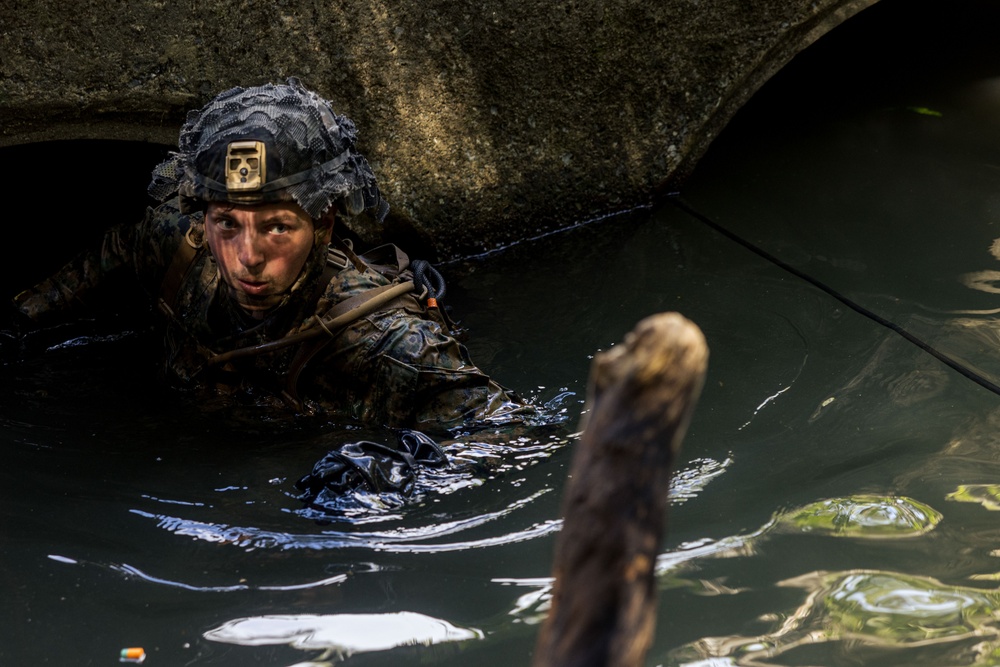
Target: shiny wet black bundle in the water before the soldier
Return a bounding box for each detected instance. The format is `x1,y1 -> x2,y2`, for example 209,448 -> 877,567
295,430 -> 448,510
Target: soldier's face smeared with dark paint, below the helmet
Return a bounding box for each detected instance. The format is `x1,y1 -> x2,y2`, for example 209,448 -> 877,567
205,203 -> 330,310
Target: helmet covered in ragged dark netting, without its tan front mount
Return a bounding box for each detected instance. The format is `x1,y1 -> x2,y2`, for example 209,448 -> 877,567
149,78 -> 389,221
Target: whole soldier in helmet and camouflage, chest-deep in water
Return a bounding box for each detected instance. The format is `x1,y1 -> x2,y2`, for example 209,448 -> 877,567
7,79 -> 534,429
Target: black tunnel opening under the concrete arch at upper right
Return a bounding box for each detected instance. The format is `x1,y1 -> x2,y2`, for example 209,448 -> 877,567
692,0 -> 1000,183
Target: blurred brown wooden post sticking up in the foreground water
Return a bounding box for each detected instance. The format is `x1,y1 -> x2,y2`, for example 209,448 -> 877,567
534,313 -> 708,667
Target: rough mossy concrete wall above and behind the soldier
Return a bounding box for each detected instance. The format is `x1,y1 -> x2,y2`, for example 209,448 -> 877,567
0,0 -> 875,257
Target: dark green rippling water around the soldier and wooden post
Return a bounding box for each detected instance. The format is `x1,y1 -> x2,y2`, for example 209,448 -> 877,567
9,0 -> 1000,667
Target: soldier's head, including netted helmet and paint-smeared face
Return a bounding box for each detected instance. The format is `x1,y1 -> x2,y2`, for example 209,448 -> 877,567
149,79 -> 389,311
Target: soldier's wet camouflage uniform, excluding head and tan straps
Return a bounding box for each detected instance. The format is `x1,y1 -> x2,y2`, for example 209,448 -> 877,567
15,200 -> 534,428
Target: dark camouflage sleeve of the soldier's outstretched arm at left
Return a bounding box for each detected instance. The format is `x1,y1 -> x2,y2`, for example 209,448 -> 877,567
14,205 -> 186,324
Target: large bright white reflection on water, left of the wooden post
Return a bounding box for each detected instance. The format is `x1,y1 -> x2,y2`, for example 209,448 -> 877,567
202,611 -> 485,664
